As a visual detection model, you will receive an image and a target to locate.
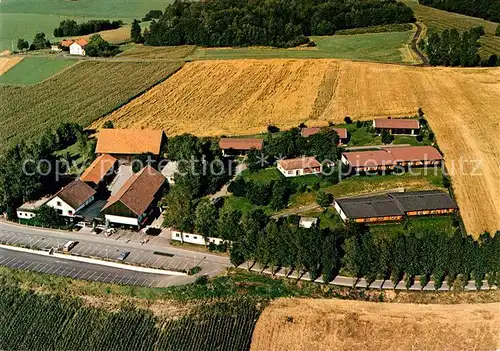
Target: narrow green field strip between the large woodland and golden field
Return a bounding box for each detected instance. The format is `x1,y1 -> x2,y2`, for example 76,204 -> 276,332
188,31 -> 414,63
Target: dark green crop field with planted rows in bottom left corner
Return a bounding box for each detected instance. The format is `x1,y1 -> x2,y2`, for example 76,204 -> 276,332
0,286 -> 260,350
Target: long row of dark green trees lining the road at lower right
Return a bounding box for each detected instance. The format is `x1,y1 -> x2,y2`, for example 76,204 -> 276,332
230,210 -> 500,288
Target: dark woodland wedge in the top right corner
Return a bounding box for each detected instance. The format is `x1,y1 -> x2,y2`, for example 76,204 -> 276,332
419,0 -> 500,22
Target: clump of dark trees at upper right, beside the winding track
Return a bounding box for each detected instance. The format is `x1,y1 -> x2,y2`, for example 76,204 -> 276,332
425,27 -> 498,67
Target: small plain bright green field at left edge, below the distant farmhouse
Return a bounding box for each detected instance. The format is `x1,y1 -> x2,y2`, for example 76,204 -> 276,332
0,56 -> 76,85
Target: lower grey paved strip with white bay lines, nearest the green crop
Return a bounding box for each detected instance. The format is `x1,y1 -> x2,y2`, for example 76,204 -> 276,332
0,248 -> 195,287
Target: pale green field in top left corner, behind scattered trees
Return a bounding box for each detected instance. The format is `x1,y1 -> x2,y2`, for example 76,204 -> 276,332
0,0 -> 171,50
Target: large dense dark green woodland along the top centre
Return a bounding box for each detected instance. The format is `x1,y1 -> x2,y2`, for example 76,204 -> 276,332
144,0 -> 415,47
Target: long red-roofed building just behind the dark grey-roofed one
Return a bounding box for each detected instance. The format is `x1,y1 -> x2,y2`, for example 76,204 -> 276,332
341,146 -> 443,172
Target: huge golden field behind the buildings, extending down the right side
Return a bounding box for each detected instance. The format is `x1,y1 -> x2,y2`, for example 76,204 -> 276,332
93,59 -> 500,234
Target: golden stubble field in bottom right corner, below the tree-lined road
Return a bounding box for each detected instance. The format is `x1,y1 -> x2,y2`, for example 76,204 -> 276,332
251,299 -> 500,351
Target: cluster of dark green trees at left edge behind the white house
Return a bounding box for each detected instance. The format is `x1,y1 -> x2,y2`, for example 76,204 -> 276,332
0,123 -> 95,218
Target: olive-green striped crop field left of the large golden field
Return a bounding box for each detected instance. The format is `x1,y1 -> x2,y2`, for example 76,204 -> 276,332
0,60 -> 182,146
